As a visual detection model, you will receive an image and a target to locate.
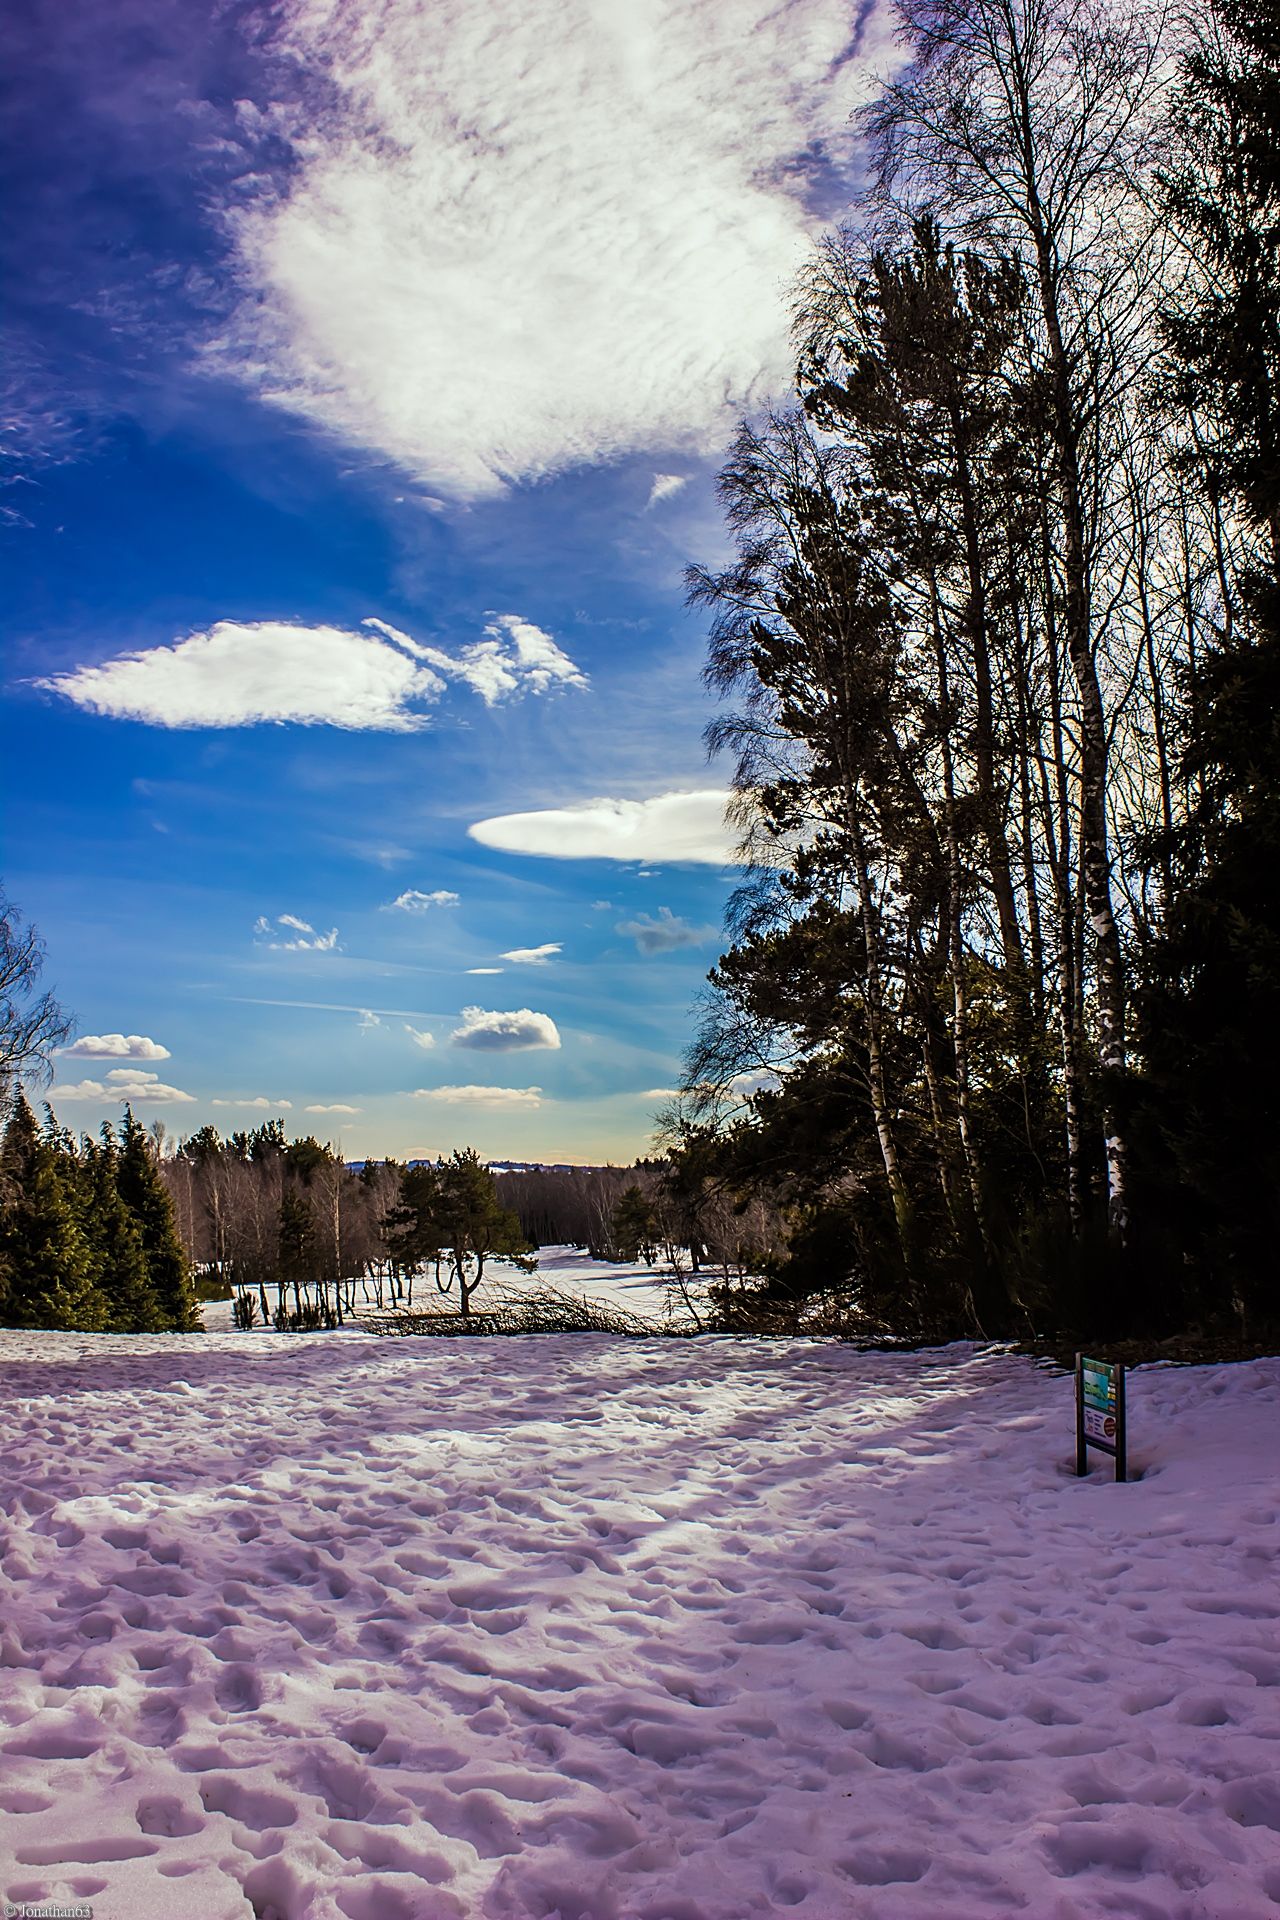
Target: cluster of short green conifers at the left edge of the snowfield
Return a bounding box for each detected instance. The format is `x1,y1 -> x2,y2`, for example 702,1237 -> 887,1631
0,1091 -> 201,1332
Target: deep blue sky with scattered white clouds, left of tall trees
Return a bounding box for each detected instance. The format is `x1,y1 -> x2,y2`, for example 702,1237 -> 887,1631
0,0 -> 892,1162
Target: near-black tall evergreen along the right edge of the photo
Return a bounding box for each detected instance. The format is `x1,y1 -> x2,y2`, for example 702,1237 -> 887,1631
1136,0 -> 1280,1319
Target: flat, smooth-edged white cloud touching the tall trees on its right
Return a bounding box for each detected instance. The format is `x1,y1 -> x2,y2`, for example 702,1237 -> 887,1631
468,787 -> 737,866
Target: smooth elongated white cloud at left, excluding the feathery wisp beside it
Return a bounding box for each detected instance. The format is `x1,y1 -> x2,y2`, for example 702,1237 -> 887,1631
36,620 -> 445,733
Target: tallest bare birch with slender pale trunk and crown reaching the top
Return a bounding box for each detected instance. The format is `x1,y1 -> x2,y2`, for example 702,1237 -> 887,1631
865,0 -> 1161,1240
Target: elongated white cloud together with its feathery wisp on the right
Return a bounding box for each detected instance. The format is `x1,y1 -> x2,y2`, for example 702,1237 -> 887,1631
35,614 -> 587,733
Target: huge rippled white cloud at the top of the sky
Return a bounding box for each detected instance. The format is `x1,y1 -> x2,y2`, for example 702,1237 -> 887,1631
221,0 -> 889,499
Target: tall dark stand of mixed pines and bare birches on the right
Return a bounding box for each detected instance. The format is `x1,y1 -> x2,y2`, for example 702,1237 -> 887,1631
670,0 -> 1280,1334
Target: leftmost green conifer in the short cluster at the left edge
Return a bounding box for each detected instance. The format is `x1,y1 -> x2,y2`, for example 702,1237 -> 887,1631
0,1092 -> 107,1332
